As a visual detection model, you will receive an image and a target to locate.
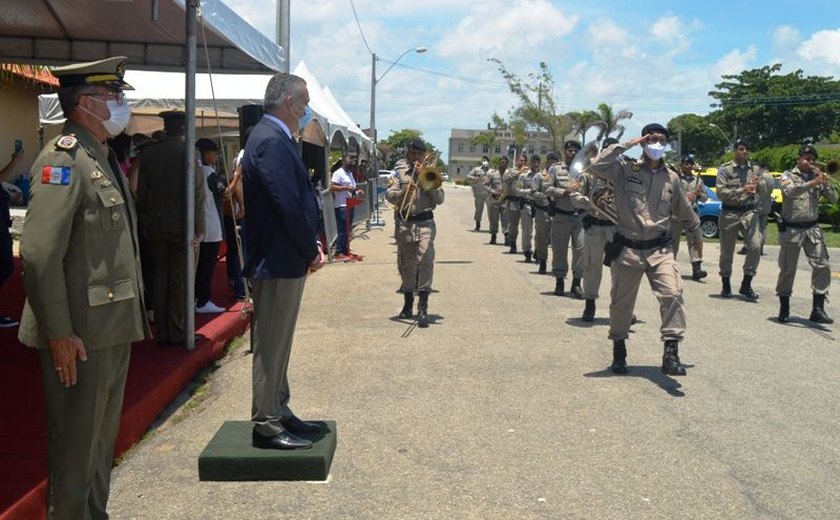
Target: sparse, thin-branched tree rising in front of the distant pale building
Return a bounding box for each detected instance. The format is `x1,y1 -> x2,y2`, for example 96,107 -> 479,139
488,58 -> 572,149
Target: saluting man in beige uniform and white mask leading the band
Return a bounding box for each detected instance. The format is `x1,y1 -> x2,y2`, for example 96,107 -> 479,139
589,123 -> 700,375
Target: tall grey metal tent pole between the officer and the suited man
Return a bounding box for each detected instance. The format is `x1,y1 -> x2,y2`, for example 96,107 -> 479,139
184,0 -> 200,350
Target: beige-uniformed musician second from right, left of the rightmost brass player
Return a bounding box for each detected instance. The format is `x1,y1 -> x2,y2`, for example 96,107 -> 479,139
716,140 -> 768,302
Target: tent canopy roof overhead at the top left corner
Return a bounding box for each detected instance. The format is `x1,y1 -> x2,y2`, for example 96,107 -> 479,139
0,0 -> 286,74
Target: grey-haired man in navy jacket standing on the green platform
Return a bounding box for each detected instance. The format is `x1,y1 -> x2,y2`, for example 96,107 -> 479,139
242,72 -> 325,450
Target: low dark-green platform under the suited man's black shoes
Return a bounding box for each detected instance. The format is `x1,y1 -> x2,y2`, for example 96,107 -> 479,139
198,421 -> 338,481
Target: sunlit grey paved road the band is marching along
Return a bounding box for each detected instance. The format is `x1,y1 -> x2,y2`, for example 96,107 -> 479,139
110,188 -> 840,519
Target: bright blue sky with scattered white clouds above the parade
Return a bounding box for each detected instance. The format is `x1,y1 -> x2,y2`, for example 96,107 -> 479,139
128,0 -> 840,160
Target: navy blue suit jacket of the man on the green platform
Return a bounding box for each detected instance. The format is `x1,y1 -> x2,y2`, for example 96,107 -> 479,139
242,112 -> 318,279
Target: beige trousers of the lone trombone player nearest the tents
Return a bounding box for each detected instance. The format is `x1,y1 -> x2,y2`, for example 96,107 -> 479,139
397,220 -> 437,293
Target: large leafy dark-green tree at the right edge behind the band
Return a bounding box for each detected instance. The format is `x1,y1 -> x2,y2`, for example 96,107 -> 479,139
709,63 -> 840,149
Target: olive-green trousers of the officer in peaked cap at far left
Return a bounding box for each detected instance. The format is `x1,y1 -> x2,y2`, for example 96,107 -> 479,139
39,344 -> 131,520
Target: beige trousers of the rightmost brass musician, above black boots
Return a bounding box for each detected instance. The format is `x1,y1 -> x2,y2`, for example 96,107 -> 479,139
776,226 -> 831,296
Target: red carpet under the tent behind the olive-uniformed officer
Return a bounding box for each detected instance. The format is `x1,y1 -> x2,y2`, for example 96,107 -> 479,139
0,259 -> 250,520
